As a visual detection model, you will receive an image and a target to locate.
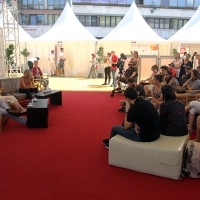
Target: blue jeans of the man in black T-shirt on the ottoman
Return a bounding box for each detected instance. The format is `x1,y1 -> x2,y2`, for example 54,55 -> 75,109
110,126 -> 142,142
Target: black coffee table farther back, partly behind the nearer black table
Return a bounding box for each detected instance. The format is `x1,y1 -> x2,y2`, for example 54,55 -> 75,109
35,90 -> 62,105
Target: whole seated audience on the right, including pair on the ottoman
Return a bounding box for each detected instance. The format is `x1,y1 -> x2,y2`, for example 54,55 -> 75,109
103,52 -> 200,148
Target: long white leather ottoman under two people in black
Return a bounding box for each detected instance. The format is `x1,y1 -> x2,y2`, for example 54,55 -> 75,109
109,135 -> 189,180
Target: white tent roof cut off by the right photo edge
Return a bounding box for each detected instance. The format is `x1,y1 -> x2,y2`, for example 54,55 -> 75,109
168,7 -> 200,44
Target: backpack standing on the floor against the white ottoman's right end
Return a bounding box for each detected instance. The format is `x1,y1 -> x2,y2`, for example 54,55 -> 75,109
181,140 -> 200,178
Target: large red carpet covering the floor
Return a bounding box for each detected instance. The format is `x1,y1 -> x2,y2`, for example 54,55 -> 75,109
0,92 -> 199,200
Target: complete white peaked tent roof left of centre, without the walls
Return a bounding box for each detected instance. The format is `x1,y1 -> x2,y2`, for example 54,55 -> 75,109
35,2 -> 97,42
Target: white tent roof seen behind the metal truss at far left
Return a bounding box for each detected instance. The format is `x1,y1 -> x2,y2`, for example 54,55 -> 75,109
0,10 -> 34,42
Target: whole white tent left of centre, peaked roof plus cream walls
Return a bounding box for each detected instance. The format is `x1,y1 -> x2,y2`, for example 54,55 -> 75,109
28,3 -> 97,76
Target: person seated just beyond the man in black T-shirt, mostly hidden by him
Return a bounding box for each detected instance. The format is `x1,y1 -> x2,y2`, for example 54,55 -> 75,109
118,77 -> 145,111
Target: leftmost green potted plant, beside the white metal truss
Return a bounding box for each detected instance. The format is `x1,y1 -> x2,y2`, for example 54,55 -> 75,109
5,44 -> 15,73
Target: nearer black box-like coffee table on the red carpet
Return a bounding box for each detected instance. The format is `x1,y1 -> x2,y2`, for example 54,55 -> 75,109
26,99 -> 48,128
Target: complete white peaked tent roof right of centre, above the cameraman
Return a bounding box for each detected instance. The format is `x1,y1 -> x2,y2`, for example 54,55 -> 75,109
100,2 -> 165,44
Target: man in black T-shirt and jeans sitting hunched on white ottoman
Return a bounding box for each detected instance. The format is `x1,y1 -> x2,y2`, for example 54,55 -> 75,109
103,87 -> 161,148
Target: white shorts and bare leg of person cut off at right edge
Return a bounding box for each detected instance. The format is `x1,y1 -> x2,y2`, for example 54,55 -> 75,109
185,101 -> 200,133
